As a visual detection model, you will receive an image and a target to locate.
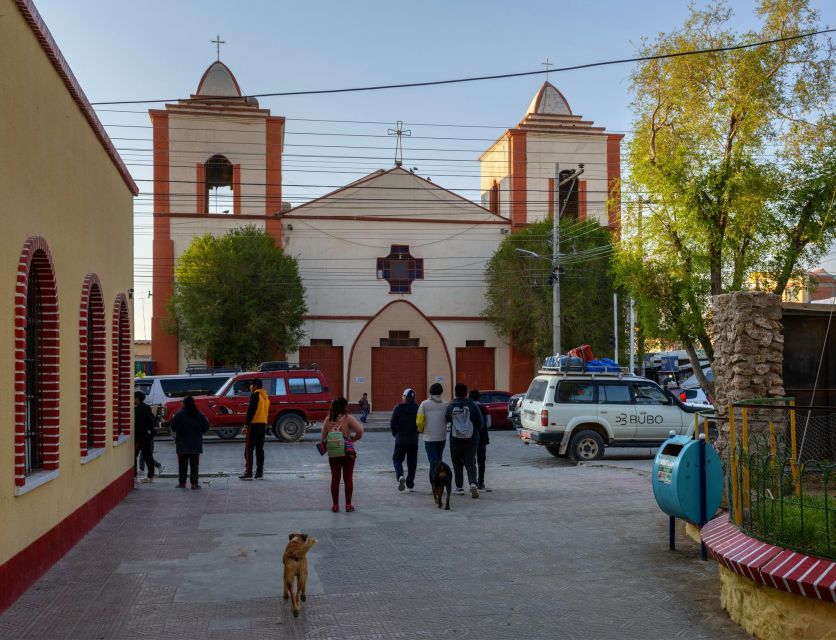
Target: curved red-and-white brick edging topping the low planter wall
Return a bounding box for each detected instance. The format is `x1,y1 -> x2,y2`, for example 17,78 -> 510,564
701,515 -> 836,602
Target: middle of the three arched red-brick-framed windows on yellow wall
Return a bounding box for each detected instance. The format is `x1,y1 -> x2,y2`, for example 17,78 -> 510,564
78,273 -> 107,458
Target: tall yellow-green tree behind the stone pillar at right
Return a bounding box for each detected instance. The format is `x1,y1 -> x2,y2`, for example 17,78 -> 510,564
617,0 -> 836,389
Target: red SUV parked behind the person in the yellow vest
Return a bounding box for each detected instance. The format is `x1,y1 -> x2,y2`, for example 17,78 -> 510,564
164,365 -> 331,442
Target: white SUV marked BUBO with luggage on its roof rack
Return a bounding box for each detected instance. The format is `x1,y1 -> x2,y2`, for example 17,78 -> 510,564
519,369 -> 699,460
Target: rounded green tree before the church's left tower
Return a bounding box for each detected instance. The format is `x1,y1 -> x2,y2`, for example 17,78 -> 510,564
169,226 -> 307,369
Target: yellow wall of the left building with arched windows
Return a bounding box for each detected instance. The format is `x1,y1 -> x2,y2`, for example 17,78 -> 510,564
0,0 -> 133,565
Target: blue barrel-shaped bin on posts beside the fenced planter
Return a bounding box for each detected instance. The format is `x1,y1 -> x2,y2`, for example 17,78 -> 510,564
652,436 -> 723,525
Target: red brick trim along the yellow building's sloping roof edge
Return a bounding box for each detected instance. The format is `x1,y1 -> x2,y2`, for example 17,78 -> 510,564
16,0 -> 139,195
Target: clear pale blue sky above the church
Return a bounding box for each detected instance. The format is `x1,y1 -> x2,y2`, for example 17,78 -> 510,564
36,0 -> 836,339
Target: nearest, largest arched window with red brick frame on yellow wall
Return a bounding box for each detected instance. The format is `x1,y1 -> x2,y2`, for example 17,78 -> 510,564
15,236 -> 60,487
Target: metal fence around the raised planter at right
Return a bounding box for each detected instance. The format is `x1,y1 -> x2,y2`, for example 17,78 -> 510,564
727,398 -> 836,558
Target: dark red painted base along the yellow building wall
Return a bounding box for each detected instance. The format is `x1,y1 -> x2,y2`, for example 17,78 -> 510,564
0,468 -> 134,613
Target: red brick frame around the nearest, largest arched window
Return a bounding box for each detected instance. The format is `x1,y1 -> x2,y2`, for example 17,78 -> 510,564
15,236 -> 60,487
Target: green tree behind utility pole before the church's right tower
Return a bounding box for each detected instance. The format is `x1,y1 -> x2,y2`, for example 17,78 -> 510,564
483,219 -> 615,360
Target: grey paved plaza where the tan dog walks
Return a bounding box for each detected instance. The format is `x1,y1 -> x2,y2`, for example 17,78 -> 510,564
0,432 -> 746,640
